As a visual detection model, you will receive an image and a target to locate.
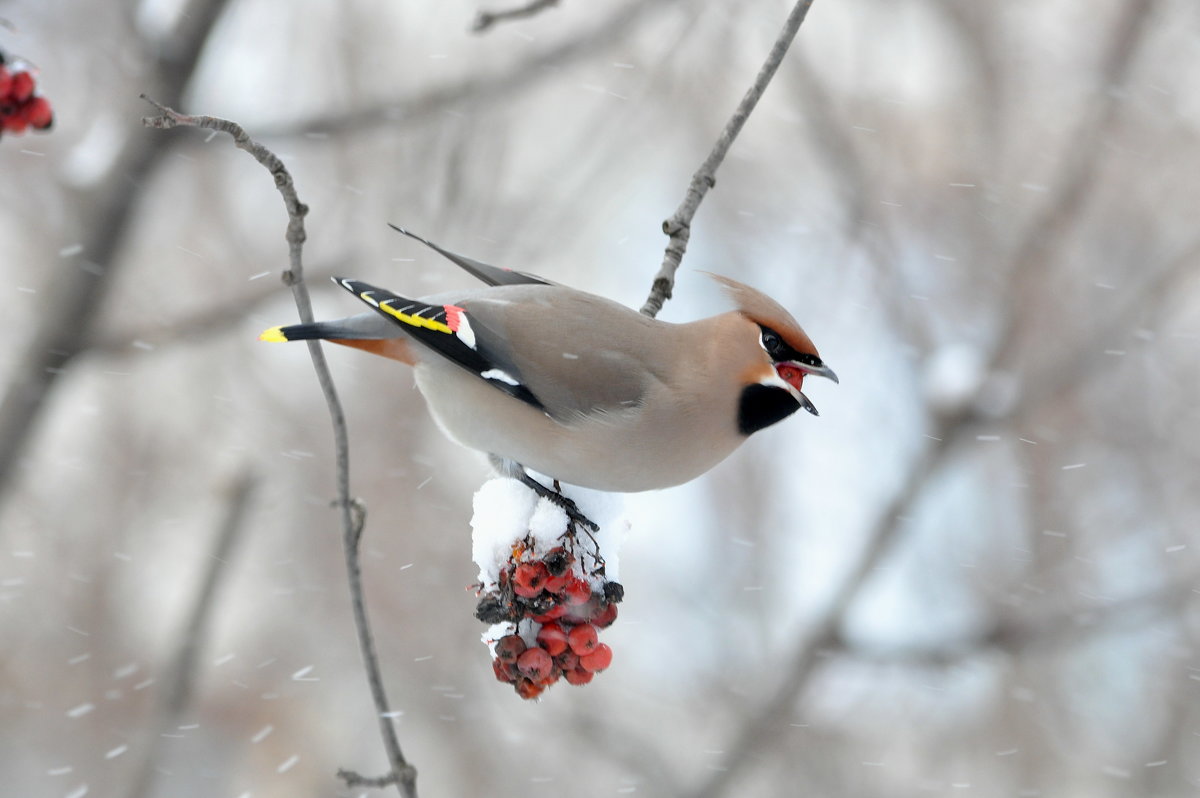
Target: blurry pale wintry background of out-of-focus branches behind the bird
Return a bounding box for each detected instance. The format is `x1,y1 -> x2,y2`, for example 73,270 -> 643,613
0,0 -> 1200,798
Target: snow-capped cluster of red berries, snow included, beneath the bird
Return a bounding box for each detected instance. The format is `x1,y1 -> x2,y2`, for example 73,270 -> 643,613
472,478 -> 629,698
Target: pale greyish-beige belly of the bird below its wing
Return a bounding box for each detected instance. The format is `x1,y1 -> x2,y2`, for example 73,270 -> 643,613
415,365 -> 742,493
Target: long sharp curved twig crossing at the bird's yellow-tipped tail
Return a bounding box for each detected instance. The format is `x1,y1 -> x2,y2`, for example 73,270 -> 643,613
142,95 -> 416,798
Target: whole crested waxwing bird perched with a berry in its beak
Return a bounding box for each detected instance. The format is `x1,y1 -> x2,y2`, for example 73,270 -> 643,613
259,228 -> 838,504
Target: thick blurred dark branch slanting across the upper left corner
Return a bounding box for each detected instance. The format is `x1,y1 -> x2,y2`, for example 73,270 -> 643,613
0,0 -> 228,511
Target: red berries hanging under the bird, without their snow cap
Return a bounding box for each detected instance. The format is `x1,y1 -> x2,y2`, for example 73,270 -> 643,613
475,546 -> 624,698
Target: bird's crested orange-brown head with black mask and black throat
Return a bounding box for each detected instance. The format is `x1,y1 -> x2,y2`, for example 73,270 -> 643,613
710,275 -> 838,434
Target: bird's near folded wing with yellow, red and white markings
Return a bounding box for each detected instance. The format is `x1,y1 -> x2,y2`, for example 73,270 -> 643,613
335,278 -> 656,424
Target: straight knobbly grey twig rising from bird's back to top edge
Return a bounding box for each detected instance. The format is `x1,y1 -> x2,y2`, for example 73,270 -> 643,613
642,0 -> 812,318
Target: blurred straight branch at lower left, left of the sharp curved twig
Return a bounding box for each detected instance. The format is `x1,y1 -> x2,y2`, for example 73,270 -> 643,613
127,472 -> 258,798
